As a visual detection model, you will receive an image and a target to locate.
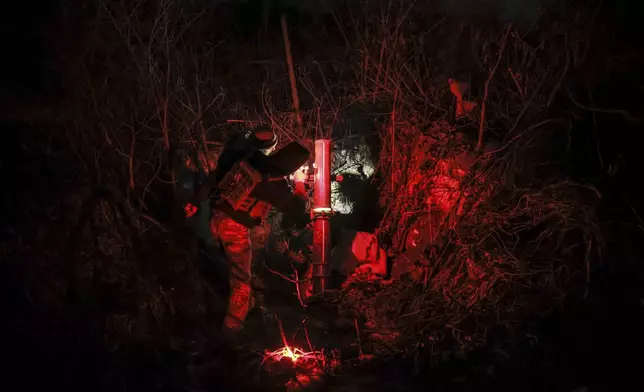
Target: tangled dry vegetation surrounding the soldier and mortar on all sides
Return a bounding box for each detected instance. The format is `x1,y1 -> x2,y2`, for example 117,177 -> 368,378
6,0 -> 640,391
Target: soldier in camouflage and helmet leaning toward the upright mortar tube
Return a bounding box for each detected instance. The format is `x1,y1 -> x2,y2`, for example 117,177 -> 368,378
186,128 -> 309,332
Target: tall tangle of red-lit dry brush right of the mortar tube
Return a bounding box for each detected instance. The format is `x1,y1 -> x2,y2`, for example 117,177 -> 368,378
330,2 -> 602,354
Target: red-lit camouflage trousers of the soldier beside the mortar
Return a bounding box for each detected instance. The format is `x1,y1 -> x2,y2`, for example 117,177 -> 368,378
210,212 -> 267,330
